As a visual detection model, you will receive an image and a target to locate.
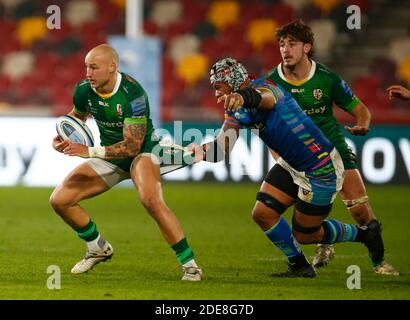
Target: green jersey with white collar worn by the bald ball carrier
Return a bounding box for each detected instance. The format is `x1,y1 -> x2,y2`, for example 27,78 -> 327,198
73,73 -> 158,171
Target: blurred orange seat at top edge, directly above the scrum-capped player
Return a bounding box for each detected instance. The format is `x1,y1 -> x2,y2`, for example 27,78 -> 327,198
208,0 -> 241,31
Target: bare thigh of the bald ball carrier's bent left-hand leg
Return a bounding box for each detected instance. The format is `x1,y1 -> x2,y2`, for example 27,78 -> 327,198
51,162 -> 110,205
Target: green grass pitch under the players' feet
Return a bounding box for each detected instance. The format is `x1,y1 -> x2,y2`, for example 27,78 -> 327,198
0,182 -> 410,300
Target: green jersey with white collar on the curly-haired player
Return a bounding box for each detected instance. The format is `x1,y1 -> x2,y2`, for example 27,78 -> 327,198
266,60 -> 360,169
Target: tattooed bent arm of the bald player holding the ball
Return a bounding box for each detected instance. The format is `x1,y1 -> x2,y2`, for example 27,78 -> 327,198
104,124 -> 147,159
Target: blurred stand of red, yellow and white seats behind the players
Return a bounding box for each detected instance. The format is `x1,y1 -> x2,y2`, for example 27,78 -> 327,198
0,0 -> 410,124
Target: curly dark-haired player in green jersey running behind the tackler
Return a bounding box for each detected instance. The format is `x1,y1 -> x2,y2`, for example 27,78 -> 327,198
267,21 -> 399,275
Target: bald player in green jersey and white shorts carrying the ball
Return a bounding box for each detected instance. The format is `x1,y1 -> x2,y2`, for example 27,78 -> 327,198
50,44 -> 202,281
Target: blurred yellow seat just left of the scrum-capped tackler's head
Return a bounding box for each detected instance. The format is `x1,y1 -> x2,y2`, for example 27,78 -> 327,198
177,54 -> 209,86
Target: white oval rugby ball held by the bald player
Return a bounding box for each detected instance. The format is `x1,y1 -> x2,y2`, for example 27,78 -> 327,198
56,115 -> 94,147
